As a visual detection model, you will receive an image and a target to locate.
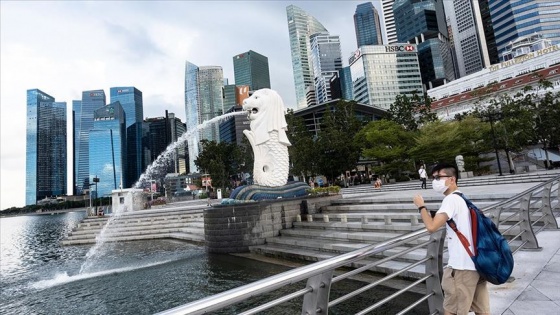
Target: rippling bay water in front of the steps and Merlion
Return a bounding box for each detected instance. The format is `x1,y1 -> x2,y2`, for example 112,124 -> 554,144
0,212 -> 425,315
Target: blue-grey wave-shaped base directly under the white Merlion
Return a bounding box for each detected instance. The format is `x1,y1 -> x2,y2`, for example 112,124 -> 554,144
223,182 -> 311,203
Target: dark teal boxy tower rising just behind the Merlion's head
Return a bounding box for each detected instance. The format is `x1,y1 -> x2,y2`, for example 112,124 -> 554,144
233,50 -> 270,91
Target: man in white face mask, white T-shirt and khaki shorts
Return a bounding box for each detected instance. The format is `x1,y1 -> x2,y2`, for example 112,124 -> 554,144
413,163 -> 490,315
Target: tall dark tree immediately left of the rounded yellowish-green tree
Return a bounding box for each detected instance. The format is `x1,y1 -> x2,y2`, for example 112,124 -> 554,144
313,101 -> 362,181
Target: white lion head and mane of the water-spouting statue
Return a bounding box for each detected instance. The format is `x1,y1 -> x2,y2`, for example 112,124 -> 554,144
243,89 -> 290,145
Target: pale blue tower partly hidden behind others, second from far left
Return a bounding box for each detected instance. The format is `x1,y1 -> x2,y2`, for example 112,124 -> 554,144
72,90 -> 106,195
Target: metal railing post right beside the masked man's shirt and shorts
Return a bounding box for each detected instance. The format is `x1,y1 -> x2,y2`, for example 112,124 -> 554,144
426,229 -> 445,314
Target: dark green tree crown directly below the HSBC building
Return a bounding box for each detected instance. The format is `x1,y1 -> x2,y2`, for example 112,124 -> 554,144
388,93 -> 437,131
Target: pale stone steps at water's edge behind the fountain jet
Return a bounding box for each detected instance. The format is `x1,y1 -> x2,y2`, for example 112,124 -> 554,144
62,208 -> 204,245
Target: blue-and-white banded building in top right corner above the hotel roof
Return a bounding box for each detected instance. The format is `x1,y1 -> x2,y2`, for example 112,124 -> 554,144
489,0 -> 560,54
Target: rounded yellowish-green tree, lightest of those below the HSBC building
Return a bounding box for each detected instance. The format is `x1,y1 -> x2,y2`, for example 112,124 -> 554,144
356,119 -> 414,177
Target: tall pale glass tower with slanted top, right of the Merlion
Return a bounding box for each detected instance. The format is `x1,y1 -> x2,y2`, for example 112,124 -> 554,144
286,5 -> 328,108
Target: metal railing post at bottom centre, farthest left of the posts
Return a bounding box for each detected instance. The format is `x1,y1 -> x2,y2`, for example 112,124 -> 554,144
301,270 -> 333,315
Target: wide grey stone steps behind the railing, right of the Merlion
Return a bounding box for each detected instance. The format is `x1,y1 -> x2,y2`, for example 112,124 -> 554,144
250,172 -> 558,279
